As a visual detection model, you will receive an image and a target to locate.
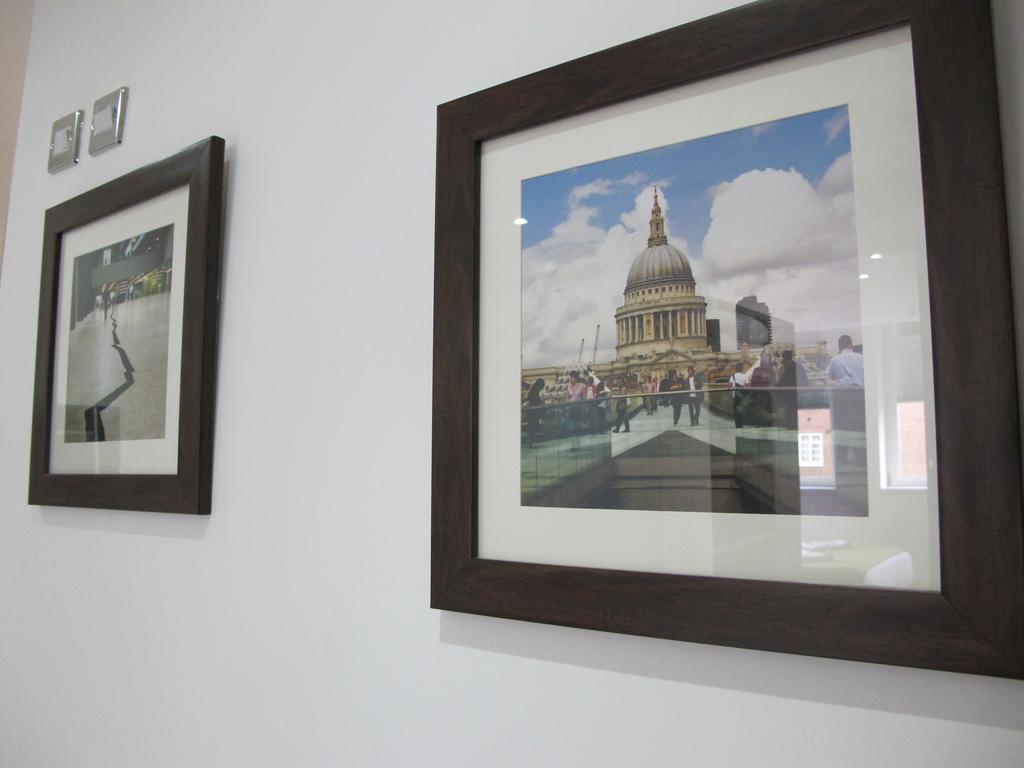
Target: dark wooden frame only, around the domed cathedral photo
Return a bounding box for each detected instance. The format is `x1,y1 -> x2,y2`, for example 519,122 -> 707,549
431,0 -> 1024,678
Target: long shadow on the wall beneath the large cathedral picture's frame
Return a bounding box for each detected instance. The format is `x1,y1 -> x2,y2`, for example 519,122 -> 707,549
439,611 -> 1024,731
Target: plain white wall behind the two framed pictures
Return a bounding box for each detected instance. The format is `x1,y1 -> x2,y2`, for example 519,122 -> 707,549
0,0 -> 1024,768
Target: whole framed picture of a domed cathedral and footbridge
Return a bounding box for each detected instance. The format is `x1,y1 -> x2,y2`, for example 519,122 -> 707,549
431,0 -> 1024,677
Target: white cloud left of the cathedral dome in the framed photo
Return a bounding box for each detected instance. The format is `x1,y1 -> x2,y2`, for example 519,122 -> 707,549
522,183 -> 687,368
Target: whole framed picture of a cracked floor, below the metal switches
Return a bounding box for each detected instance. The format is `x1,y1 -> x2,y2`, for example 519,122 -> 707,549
29,136 -> 224,514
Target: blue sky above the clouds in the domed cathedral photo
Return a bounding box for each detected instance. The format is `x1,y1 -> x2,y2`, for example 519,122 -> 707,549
522,105 -> 850,258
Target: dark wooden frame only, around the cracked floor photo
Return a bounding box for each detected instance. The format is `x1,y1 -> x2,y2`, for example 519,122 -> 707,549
29,136 -> 224,514
